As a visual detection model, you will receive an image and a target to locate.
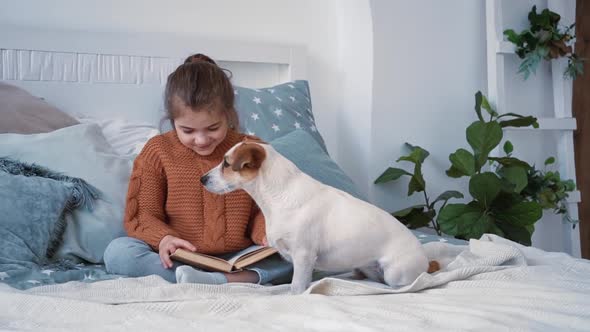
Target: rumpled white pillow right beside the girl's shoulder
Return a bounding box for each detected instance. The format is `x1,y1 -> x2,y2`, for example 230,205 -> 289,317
76,114 -> 160,156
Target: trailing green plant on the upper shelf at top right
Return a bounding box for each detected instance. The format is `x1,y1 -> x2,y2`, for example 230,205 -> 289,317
504,6 -> 584,80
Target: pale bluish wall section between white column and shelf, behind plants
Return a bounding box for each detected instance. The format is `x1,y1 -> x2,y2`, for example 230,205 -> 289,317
369,0 -> 487,211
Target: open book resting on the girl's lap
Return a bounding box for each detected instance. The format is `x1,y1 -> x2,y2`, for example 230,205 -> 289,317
170,245 -> 277,272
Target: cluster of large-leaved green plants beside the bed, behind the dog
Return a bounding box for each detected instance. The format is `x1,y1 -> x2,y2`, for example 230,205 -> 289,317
375,91 -> 575,245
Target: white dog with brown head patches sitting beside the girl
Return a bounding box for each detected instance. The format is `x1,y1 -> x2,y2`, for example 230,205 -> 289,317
201,139 -> 438,294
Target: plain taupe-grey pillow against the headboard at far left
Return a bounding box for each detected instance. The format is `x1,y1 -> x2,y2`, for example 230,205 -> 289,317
0,82 -> 79,134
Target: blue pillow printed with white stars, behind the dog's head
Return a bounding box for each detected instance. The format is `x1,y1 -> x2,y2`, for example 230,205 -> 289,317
234,80 -> 327,151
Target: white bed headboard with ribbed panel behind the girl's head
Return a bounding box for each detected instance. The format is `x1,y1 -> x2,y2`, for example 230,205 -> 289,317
0,26 -> 306,125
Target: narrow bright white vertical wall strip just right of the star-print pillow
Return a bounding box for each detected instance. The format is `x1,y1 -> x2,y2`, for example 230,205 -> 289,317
334,0 -> 374,194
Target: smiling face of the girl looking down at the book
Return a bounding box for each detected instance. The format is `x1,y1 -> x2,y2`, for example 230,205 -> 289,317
174,105 -> 229,156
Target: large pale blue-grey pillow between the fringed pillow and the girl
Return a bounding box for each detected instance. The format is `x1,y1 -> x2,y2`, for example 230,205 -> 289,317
0,124 -> 133,263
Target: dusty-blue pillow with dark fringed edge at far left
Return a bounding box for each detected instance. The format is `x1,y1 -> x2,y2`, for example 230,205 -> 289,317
0,171 -> 74,273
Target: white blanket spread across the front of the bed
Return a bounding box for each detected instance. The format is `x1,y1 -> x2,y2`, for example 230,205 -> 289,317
0,235 -> 590,332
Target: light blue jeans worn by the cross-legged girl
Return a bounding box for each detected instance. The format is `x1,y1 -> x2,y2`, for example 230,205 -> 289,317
104,237 -> 293,284
